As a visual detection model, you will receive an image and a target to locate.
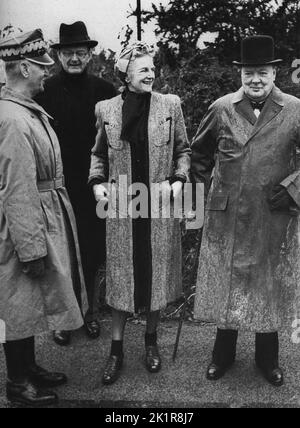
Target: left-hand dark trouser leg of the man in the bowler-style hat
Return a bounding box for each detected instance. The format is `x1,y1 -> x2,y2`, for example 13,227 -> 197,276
213,329 -> 238,367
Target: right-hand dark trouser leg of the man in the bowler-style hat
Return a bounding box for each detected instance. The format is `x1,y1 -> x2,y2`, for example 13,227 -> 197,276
255,332 -> 279,369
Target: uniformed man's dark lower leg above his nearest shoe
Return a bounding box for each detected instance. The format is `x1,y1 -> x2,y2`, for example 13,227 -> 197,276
3,337 -> 35,382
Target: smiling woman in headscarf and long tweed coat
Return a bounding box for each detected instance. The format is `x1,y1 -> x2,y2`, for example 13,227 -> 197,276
90,43 -> 190,385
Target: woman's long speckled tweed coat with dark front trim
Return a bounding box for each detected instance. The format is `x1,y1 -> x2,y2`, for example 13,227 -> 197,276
90,93 -> 191,312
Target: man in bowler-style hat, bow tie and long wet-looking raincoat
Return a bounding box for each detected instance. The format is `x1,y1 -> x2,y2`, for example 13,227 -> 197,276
192,36 -> 300,386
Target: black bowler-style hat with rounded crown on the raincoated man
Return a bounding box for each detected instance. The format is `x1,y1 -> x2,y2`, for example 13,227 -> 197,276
233,36 -> 282,66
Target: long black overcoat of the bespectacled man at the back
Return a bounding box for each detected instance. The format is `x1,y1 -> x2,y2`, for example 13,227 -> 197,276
36,70 -> 117,318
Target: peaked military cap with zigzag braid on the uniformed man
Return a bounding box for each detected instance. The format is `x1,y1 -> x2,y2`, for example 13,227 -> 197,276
0,29 -> 54,66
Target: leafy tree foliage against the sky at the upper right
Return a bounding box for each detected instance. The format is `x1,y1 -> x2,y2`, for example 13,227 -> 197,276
144,0 -> 300,64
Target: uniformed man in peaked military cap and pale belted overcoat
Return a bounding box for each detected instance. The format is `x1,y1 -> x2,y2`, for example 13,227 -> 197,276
0,30 -> 85,405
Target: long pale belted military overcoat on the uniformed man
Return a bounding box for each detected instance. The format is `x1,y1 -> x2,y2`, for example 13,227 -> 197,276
0,88 -> 86,341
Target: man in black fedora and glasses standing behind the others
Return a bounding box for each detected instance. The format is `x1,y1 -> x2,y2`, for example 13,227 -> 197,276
37,22 -> 116,345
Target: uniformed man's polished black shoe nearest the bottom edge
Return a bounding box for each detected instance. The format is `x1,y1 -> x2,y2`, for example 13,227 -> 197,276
6,380 -> 58,407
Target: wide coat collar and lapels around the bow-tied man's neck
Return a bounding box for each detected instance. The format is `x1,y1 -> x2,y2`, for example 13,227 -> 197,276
232,86 -> 284,138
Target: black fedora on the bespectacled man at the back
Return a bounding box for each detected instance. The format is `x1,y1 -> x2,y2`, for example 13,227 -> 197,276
51,21 -> 98,49
